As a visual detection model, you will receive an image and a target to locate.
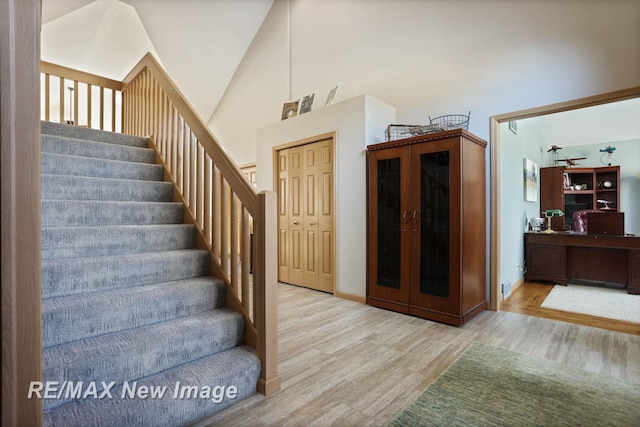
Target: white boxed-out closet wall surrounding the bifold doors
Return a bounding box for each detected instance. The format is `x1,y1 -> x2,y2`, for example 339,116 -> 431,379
257,95 -> 395,297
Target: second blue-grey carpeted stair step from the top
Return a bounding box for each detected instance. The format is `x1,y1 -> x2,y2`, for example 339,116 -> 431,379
42,135 -> 156,163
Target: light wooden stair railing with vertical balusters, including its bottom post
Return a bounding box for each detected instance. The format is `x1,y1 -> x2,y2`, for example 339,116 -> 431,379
41,53 -> 280,394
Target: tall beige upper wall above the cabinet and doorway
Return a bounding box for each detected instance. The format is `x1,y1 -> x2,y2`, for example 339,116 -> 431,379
209,0 -> 640,164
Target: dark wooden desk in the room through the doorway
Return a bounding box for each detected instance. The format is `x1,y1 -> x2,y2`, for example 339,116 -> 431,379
524,232 -> 640,294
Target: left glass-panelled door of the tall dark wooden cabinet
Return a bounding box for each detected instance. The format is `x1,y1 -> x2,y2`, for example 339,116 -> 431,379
369,147 -> 410,304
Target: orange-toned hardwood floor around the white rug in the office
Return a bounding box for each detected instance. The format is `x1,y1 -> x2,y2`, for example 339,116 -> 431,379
501,282 -> 640,335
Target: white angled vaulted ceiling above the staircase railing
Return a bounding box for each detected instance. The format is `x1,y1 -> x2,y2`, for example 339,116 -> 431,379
41,0 -> 273,123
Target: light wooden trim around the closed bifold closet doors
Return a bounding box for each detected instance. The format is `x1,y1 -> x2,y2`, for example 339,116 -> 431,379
272,132 -> 340,296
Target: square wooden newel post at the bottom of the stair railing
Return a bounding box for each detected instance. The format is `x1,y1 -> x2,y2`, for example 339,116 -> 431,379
254,191 -> 280,395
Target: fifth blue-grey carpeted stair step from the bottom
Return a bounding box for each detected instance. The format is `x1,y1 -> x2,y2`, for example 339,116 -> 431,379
41,224 -> 196,260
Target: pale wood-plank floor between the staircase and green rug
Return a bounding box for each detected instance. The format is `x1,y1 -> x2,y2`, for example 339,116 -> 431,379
196,284 -> 640,427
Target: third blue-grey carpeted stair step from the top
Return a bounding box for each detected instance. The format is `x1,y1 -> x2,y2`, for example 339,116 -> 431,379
40,153 -> 164,181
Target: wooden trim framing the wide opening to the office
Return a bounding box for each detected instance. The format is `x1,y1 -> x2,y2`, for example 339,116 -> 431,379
489,86 -> 640,310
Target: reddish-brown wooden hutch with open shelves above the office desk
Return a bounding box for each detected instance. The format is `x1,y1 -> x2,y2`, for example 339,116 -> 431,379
540,166 -> 620,231
